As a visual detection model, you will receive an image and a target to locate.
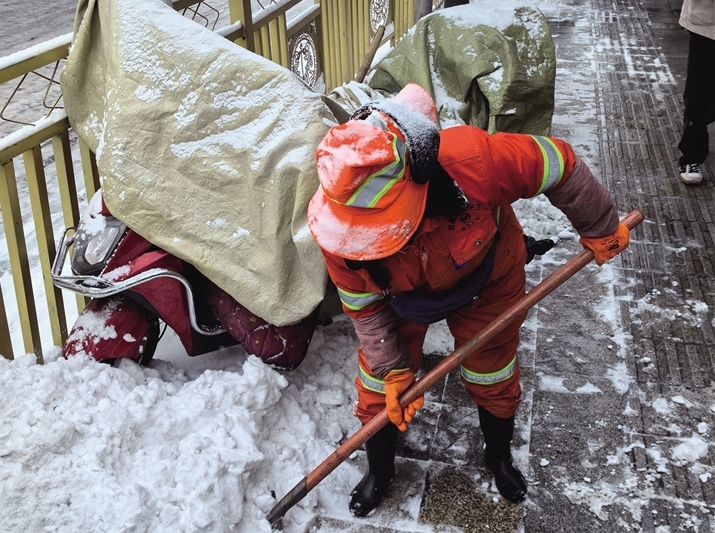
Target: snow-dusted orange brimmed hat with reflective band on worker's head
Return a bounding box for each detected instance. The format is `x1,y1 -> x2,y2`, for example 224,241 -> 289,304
308,84 -> 439,260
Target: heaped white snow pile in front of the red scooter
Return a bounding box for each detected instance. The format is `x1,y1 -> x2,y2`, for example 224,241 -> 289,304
0,332 -> 355,533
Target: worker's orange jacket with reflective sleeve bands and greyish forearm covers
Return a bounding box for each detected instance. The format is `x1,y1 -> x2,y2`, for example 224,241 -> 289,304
323,126 -> 618,378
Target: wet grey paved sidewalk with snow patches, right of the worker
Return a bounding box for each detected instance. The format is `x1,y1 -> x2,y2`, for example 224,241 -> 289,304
314,0 -> 715,533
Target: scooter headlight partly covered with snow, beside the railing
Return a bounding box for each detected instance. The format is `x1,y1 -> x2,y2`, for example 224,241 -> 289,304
70,217 -> 127,275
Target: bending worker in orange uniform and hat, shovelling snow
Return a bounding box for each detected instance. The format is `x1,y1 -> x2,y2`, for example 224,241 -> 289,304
308,84 -> 628,516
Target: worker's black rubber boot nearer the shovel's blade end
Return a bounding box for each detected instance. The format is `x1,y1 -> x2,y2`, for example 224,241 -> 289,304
350,423 -> 398,517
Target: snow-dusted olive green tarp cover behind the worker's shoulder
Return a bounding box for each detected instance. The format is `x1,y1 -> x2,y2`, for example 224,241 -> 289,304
369,0 -> 556,135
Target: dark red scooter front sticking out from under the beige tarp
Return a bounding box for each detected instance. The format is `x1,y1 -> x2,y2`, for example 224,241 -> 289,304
53,189 -> 318,370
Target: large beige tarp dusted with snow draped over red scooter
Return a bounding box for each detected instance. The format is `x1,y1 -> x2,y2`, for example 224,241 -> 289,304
61,0 -> 335,325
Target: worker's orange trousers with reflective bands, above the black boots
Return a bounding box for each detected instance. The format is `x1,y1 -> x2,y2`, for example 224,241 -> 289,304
355,215 -> 527,424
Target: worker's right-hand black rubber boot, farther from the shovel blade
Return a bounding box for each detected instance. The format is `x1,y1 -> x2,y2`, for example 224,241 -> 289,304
479,406 -> 527,503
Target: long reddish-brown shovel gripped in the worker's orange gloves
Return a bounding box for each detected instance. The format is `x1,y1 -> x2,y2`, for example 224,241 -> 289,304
267,209 -> 643,530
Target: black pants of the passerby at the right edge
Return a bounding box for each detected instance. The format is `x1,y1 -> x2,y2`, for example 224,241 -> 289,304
678,32 -> 715,165
